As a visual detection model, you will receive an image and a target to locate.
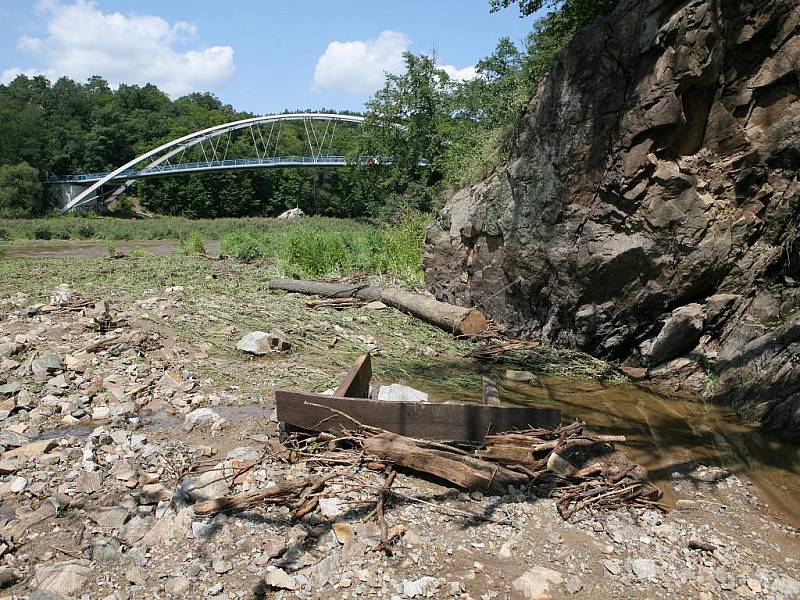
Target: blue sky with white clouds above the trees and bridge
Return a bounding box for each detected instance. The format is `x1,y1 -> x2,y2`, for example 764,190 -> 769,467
0,0 -> 533,114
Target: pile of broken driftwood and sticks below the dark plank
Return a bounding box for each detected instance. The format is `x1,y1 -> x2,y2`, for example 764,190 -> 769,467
194,414 -> 661,536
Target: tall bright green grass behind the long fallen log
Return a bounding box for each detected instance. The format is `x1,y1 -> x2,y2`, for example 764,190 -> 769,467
222,215 -> 427,283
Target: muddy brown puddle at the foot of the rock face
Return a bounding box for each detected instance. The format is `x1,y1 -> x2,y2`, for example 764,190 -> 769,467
394,364 -> 800,526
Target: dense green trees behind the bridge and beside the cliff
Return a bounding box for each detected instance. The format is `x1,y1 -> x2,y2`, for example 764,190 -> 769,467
0,0 -> 616,218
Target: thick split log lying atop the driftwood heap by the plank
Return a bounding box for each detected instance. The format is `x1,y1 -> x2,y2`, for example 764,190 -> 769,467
362,433 -> 528,494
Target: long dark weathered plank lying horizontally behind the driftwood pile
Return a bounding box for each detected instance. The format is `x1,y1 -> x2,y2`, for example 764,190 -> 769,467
275,390 -> 561,441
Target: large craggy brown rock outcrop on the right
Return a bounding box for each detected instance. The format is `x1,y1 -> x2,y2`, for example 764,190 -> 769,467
424,0 -> 800,435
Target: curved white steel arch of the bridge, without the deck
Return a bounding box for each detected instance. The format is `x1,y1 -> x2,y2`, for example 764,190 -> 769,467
61,113 -> 364,213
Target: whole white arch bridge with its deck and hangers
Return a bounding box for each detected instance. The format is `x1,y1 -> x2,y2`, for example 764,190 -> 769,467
51,113 -> 392,212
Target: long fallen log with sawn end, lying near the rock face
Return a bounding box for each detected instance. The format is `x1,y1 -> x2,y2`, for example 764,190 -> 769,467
269,279 -> 488,335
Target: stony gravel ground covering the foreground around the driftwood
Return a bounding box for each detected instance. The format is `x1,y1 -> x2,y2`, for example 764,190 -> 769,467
0,264 -> 800,600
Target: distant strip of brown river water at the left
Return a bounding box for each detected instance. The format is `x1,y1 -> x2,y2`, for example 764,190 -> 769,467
0,240 -> 219,258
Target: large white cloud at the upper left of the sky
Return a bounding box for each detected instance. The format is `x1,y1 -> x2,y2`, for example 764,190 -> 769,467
2,0 -> 236,96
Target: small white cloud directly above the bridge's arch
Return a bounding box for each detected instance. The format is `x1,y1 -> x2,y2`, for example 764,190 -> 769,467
314,30 -> 411,94
